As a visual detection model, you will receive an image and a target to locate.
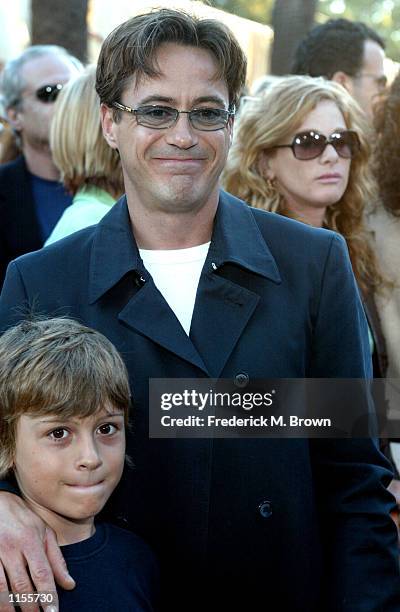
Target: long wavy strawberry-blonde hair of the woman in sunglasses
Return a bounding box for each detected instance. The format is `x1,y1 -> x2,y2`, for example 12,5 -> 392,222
223,76 -> 384,293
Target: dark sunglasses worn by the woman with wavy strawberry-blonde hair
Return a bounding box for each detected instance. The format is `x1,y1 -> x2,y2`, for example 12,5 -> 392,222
274,130 -> 360,161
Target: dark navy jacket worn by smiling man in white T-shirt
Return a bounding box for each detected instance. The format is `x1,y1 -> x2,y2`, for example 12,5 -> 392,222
0,194 -> 400,612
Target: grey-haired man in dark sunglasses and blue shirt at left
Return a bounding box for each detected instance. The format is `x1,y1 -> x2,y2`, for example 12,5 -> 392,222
0,45 -> 82,286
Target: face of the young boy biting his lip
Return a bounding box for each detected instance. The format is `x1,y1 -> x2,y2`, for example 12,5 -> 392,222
14,406 -> 125,524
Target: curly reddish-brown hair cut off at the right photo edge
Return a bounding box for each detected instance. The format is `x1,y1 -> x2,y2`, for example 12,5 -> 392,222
373,73 -> 400,217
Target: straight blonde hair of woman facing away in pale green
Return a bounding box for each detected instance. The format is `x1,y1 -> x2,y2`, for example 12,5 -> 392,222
50,66 -> 124,198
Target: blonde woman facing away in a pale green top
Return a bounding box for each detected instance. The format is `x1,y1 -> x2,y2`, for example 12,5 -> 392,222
45,66 -> 124,246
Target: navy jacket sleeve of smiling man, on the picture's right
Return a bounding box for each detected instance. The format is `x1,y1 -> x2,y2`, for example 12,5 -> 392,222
310,236 -> 400,612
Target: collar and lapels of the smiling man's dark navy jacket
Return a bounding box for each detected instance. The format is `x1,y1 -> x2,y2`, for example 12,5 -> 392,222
89,192 -> 281,377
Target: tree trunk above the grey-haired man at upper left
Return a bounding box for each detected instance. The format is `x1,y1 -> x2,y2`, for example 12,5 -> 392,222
31,0 -> 88,62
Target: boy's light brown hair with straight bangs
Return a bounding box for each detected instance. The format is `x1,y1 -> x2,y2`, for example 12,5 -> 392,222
0,318 -> 130,477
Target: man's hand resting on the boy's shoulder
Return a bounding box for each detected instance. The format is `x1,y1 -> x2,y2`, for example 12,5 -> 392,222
0,491 -> 75,612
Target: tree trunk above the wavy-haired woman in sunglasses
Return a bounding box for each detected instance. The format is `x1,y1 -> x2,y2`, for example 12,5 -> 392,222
271,0 -> 317,75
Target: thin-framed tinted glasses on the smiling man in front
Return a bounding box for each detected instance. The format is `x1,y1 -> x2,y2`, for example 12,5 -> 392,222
112,102 -> 235,132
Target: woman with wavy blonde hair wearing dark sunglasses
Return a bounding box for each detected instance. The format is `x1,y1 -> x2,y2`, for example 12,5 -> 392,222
223,76 -> 386,375
